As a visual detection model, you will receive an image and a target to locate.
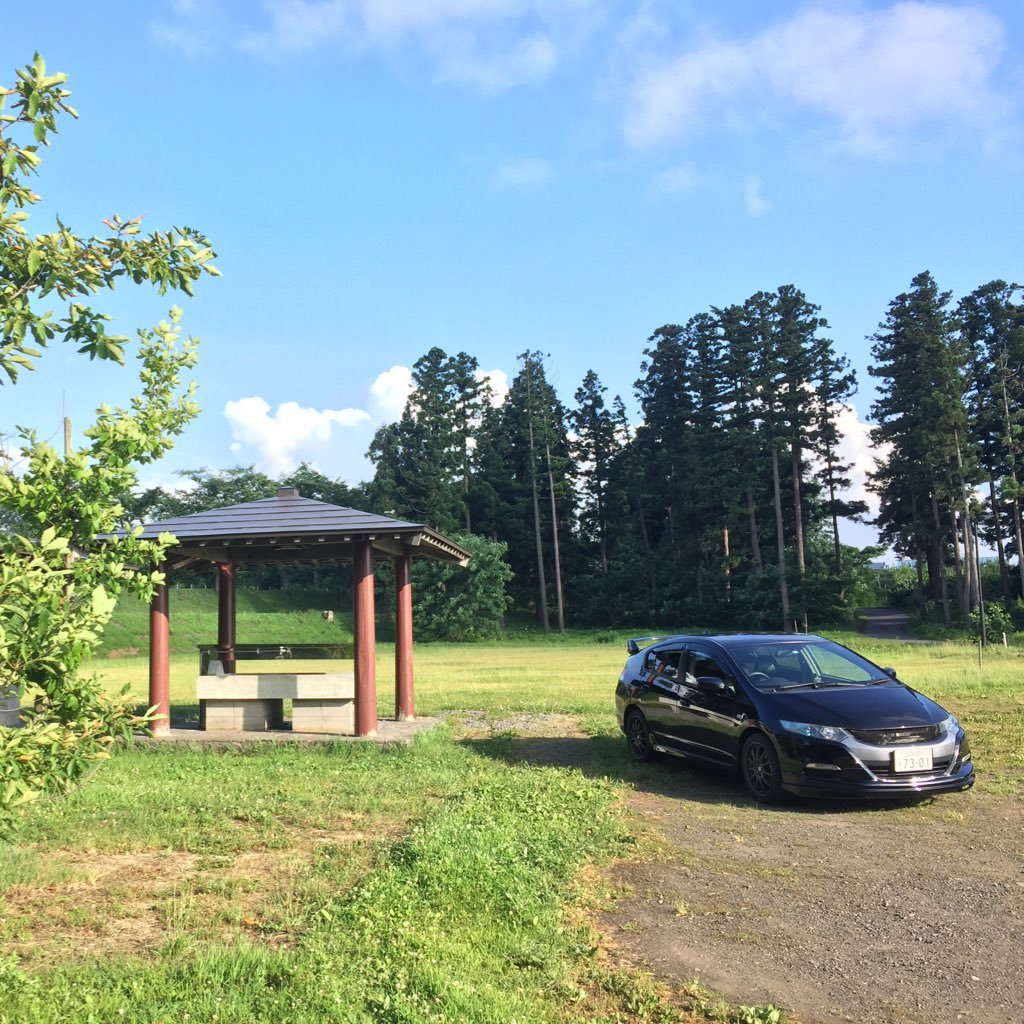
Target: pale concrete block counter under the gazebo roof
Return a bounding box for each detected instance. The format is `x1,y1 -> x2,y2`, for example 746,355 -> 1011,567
196,662 -> 355,736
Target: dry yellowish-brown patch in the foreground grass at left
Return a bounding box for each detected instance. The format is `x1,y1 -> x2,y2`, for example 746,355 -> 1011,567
0,815 -> 402,968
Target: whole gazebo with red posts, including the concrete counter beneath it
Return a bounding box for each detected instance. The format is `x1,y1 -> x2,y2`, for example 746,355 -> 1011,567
132,487 -> 469,738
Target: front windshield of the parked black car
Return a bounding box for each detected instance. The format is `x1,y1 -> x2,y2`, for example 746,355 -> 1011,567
730,639 -> 889,690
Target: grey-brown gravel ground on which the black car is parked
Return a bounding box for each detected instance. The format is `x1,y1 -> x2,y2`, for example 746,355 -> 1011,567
464,716 -> 1024,1024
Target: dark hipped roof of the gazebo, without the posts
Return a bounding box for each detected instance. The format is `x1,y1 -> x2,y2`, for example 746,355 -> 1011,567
132,487 -> 470,568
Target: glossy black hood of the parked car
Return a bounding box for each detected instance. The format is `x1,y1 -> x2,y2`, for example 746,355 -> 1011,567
759,682 -> 945,729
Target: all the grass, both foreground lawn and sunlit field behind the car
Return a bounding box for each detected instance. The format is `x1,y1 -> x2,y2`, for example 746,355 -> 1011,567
0,602 -> 1024,1024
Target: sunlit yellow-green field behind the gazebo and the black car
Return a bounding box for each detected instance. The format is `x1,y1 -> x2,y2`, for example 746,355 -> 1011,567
91,633 -> 1024,794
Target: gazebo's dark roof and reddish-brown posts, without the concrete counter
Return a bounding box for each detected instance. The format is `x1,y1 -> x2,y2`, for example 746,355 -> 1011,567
132,487 -> 469,737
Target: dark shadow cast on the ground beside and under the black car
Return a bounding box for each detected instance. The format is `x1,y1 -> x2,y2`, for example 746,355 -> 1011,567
461,734 -> 934,815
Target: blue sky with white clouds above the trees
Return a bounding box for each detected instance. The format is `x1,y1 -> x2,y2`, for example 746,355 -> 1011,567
0,0 -> 1024,541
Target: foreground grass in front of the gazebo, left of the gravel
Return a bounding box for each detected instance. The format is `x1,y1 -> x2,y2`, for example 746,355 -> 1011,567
0,733 -> 638,1024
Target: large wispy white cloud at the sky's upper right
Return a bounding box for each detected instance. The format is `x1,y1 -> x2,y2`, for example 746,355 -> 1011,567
624,0 -> 1005,155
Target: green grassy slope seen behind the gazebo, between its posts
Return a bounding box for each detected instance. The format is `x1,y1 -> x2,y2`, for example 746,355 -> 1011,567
98,590 -> 360,657
